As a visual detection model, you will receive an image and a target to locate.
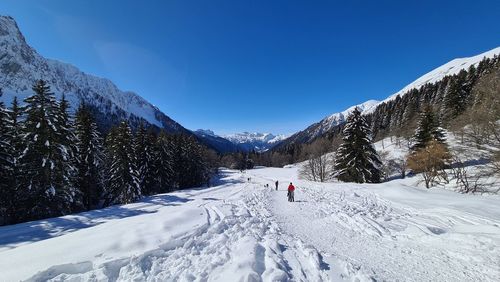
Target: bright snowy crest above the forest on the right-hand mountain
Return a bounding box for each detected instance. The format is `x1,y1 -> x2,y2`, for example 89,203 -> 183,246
281,47 -> 500,148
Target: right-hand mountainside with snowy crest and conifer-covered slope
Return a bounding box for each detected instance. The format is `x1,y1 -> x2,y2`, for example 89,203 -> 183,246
274,47 -> 500,166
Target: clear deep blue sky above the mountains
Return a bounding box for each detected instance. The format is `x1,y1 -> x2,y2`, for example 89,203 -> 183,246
0,0 -> 500,134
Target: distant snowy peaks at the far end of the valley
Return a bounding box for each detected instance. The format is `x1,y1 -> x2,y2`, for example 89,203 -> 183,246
223,132 -> 286,152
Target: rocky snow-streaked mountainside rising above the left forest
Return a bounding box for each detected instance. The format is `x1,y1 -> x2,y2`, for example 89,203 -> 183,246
0,16 -> 185,132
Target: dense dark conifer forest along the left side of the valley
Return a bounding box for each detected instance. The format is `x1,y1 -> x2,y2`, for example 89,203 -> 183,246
0,80 -> 215,225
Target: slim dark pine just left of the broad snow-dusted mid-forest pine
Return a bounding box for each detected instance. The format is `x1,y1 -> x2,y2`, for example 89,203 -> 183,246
75,104 -> 104,210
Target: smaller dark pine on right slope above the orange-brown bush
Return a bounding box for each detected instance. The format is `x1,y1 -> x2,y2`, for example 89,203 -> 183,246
412,105 -> 446,152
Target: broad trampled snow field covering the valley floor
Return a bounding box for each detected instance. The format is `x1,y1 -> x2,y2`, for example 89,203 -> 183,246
0,167 -> 500,281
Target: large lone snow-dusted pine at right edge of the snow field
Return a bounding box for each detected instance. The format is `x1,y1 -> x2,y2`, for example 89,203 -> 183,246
335,108 -> 381,183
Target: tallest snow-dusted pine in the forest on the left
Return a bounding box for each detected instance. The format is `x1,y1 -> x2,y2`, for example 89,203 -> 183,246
19,80 -> 74,219
